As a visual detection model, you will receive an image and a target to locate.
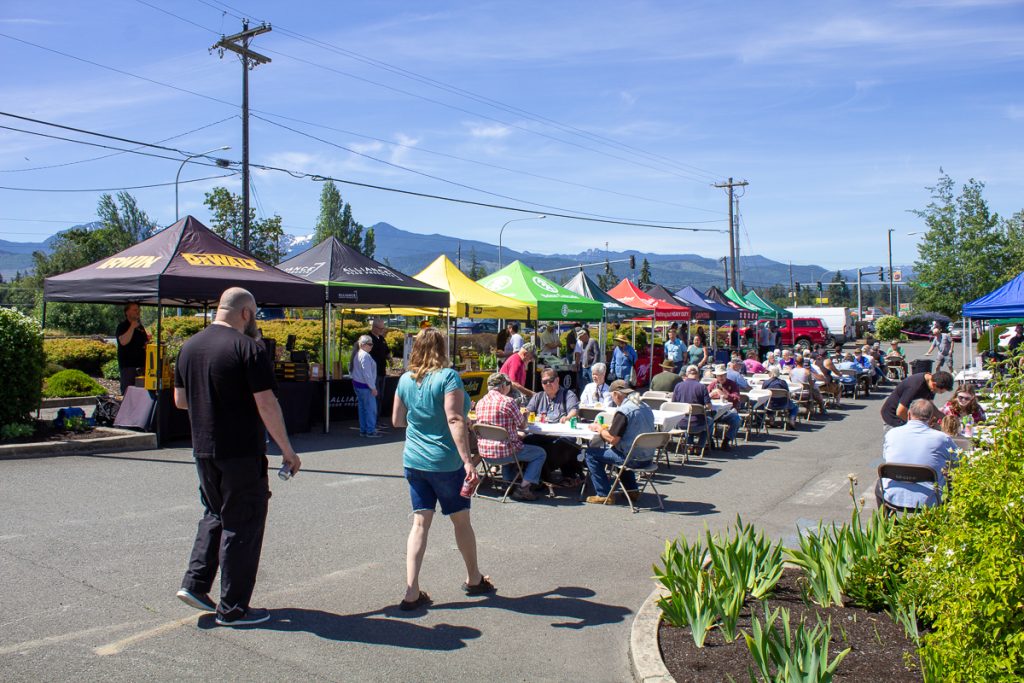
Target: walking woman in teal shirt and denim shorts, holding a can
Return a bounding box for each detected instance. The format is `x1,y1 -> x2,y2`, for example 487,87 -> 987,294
391,328 -> 495,610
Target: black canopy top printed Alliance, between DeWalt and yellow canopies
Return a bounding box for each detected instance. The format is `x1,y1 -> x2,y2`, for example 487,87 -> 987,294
278,237 -> 449,308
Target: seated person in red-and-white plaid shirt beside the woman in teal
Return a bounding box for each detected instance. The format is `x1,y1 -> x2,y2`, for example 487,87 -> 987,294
476,373 -> 547,501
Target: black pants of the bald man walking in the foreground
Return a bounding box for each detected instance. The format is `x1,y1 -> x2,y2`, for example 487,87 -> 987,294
181,456 -> 270,620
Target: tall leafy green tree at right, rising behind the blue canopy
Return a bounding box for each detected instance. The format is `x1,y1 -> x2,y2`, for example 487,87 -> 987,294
912,172 -> 1007,316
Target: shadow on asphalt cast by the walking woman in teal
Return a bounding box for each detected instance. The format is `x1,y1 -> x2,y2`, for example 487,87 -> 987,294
430,586 -> 633,629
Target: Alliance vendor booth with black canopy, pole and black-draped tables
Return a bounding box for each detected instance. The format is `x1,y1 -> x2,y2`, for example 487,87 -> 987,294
278,237 -> 449,432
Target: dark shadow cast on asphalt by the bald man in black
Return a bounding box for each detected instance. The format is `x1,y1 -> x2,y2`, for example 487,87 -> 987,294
205,607 -> 482,650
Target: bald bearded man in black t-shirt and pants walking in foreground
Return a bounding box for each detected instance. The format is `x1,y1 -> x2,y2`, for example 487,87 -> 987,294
174,287 -> 302,626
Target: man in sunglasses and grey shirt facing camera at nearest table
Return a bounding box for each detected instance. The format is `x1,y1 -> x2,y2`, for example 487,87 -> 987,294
523,368 -> 583,486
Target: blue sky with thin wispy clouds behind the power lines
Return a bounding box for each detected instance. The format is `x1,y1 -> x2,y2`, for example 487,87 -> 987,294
0,0 -> 1024,267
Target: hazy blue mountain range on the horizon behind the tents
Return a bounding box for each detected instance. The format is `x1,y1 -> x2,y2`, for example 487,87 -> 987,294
0,222 -> 912,291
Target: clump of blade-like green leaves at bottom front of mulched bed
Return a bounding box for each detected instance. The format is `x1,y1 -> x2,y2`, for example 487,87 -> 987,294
743,606 -> 851,683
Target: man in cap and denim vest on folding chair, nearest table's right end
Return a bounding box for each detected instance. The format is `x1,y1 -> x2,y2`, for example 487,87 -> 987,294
585,380 -> 654,505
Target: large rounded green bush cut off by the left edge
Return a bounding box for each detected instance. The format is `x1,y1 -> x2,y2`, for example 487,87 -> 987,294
0,308 -> 46,426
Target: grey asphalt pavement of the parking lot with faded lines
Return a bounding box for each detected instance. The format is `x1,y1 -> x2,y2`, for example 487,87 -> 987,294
0,343 -> 926,682
